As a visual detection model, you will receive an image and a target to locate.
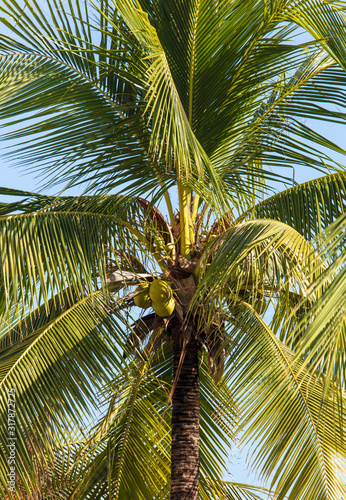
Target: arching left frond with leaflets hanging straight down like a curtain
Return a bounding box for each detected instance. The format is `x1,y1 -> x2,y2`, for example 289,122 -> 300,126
0,196 -> 151,319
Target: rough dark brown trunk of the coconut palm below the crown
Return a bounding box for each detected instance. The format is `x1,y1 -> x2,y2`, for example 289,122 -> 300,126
171,331 -> 200,500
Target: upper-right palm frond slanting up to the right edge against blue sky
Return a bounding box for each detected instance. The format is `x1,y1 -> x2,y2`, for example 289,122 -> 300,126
212,51 -> 345,201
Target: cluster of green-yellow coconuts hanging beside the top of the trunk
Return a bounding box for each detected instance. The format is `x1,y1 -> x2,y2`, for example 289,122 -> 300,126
133,280 -> 175,318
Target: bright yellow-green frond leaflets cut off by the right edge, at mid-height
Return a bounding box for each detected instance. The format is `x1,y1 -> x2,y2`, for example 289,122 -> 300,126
289,214 -> 346,396
